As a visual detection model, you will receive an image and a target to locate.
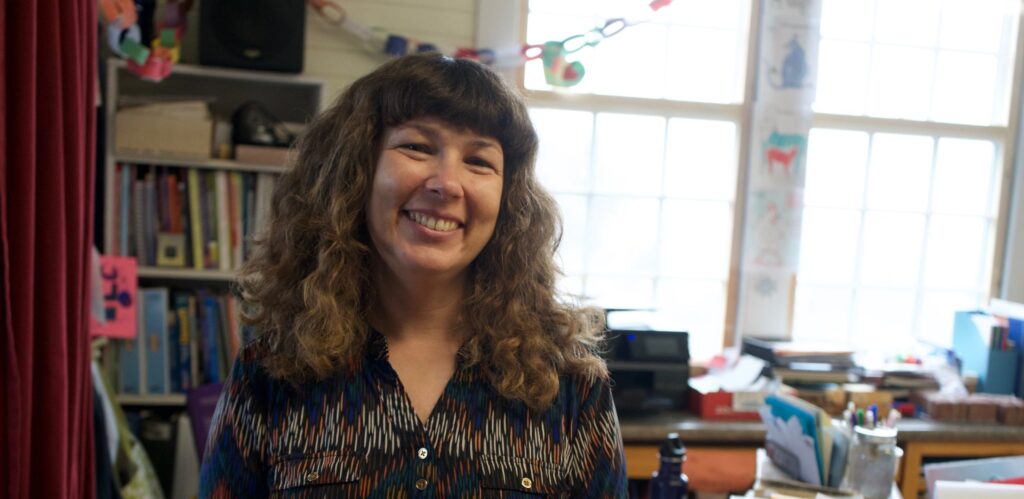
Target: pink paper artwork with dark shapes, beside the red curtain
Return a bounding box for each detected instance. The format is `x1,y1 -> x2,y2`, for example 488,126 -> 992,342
90,256 -> 138,338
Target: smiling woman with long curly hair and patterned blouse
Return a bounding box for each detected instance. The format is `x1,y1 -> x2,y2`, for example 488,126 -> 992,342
201,54 -> 626,497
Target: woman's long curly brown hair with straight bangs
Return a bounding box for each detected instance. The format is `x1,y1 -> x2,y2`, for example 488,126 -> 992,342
239,54 -> 607,408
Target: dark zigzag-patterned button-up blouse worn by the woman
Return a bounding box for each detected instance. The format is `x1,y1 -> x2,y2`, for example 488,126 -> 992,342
200,334 -> 627,498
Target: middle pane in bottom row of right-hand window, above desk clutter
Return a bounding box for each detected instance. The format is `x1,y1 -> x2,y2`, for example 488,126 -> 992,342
853,288 -> 914,352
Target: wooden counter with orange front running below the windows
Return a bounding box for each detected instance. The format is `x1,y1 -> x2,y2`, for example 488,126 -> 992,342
620,412 -> 1024,499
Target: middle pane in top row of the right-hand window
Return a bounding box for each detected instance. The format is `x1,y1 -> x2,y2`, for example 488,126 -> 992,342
874,0 -> 941,47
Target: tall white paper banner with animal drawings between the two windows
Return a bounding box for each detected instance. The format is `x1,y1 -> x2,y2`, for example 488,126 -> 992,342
739,0 -> 821,339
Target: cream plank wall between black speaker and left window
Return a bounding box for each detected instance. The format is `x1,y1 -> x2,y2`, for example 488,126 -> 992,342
303,0 -> 476,106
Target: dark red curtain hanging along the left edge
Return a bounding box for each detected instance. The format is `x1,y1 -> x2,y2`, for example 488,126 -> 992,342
0,0 -> 97,499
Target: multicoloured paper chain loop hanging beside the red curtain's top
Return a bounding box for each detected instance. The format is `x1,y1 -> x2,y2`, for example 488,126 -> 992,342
99,0 -> 193,82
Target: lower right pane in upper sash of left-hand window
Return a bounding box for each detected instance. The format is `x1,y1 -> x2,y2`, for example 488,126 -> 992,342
667,27 -> 742,102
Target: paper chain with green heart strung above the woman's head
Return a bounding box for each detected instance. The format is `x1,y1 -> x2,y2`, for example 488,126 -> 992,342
308,0 -> 673,87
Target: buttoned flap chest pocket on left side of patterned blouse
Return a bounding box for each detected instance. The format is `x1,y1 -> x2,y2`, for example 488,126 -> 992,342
269,451 -> 362,494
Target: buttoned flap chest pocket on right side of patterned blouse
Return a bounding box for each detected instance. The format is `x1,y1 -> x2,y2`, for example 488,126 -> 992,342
477,455 -> 569,498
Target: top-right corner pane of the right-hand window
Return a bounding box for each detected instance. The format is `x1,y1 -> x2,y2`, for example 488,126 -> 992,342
939,0 -> 1016,53
